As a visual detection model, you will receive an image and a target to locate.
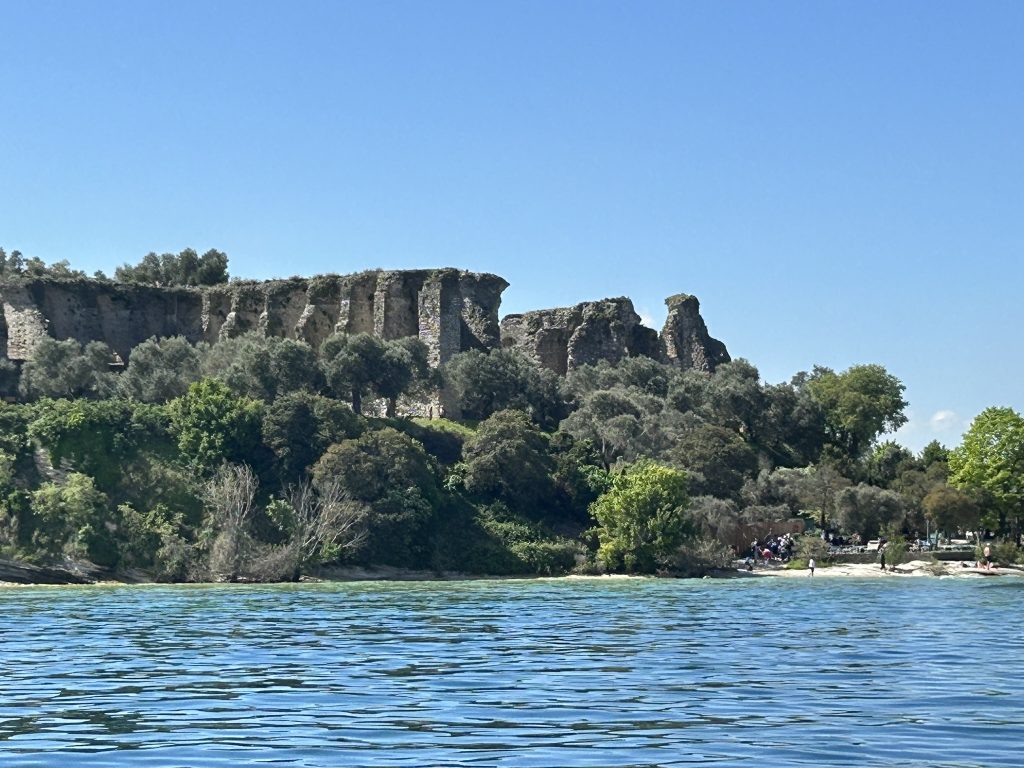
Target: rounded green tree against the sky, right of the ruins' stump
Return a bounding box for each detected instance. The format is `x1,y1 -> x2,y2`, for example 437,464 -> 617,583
807,365 -> 907,460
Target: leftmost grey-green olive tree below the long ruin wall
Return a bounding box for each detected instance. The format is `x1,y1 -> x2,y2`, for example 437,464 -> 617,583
20,339 -> 116,399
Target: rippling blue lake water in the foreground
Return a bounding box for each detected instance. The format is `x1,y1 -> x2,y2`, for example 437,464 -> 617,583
0,578 -> 1024,768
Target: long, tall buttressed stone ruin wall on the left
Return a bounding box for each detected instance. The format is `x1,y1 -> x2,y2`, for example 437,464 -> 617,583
0,269 -> 508,366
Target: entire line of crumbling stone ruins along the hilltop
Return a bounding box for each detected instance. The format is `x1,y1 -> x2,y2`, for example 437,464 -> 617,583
0,268 -> 729,415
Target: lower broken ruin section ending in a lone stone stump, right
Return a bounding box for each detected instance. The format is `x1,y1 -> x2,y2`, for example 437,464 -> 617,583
502,295 -> 729,375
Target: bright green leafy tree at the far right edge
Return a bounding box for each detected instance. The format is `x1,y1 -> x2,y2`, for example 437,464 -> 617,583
949,408 -> 1024,543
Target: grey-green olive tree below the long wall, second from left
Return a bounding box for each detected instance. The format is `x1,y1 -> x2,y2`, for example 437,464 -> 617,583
118,336 -> 200,402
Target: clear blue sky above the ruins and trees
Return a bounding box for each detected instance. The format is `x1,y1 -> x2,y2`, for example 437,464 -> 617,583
0,0 -> 1024,450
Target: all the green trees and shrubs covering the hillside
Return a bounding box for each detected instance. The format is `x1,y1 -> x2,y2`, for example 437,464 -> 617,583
0,251 -> 1024,580
